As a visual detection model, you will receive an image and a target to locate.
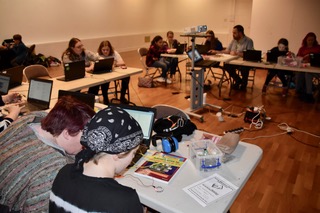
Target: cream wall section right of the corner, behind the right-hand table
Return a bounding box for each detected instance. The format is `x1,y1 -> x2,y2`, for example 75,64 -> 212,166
251,0 -> 320,53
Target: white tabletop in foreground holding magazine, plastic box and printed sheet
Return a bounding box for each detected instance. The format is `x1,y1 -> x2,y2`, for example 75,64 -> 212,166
117,130 -> 262,213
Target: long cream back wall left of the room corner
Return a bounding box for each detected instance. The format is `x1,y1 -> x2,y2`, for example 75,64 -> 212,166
0,0 -> 252,57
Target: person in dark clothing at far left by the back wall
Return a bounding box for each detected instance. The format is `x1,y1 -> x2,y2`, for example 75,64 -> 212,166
10,34 -> 28,66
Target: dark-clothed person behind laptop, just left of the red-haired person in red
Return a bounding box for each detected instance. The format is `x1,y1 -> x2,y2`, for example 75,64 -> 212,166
262,38 -> 292,96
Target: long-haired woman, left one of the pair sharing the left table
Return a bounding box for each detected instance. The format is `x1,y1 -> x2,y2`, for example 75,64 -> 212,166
62,38 -> 99,72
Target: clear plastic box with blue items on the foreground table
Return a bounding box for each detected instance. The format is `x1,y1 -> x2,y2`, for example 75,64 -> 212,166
190,140 -> 223,172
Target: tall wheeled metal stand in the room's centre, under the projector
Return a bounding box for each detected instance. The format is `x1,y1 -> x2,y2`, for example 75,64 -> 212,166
181,34 -> 222,122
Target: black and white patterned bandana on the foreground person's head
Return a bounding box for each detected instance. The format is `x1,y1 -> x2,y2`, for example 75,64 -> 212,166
81,106 -> 143,154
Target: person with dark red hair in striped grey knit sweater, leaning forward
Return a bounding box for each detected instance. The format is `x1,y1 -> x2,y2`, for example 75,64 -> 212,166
0,96 -> 95,212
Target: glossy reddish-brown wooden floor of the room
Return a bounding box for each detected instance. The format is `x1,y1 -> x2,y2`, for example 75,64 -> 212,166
51,51 -> 320,213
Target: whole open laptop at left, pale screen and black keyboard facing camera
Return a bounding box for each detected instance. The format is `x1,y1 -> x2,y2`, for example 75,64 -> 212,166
23,78 -> 53,112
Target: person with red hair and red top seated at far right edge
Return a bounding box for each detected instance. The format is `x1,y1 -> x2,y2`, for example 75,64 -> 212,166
296,32 -> 320,103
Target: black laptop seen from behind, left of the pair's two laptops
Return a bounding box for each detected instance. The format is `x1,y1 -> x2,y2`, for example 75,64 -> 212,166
57,60 -> 86,81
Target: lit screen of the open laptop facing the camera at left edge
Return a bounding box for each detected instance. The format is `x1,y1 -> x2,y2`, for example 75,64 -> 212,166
28,79 -> 53,103
